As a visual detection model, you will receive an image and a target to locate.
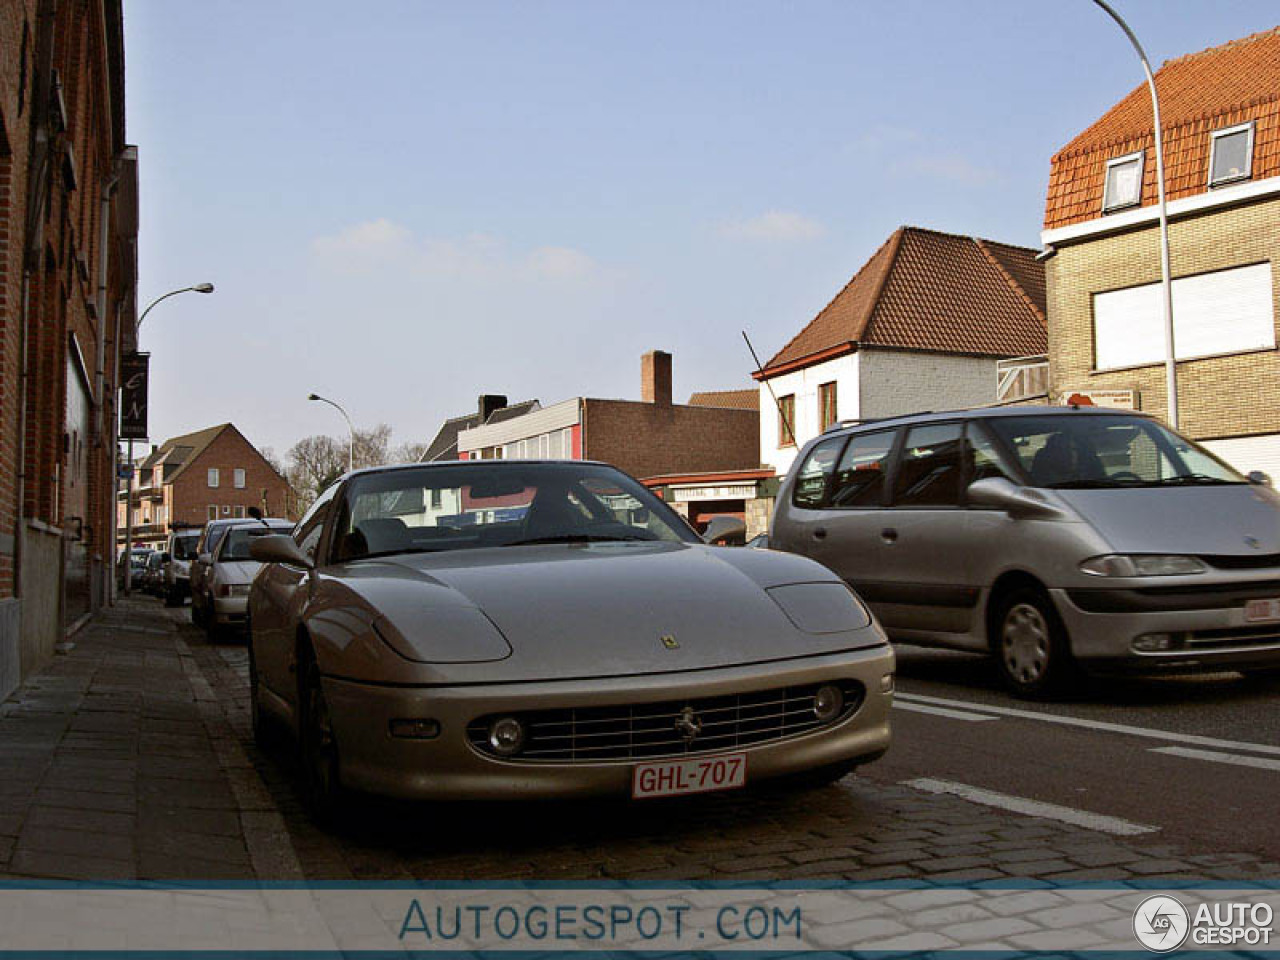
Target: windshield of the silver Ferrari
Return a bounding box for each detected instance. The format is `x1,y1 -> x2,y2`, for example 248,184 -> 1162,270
332,462 -> 698,561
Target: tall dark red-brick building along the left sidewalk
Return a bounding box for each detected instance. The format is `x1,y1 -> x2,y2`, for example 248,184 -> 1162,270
0,0 -> 137,698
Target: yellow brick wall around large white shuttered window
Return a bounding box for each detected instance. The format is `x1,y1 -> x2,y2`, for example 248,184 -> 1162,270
1046,200 -> 1280,439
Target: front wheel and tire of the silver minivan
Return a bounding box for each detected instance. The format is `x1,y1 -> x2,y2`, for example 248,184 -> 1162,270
991,586 -> 1078,700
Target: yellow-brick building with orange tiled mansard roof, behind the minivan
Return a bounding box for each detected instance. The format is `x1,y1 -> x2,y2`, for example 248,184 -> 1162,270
1042,28 -> 1280,475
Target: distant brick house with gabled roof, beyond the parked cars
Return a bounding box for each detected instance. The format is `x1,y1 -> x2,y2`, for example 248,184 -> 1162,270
116,424 -> 294,548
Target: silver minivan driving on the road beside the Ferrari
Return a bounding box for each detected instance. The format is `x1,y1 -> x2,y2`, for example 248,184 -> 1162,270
769,407 -> 1280,696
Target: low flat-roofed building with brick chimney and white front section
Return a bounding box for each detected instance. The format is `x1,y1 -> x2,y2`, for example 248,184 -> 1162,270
457,351 -> 759,477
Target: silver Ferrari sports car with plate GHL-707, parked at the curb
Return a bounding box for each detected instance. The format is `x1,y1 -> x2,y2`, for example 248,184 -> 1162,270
250,461 -> 893,815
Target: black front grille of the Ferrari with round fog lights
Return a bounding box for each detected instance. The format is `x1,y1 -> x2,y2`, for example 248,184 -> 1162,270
467,680 -> 865,763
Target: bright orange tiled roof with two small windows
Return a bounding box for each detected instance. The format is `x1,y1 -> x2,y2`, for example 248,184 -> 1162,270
1044,27 -> 1280,229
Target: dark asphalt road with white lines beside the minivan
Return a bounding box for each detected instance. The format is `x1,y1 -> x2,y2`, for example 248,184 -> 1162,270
865,646 -> 1280,859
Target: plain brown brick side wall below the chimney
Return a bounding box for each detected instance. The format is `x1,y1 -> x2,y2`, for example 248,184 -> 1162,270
582,399 -> 760,477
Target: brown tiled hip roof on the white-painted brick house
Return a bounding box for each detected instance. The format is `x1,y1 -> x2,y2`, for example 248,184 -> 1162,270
764,227 -> 1047,372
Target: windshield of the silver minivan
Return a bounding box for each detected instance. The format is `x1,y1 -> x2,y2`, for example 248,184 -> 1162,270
983,413 -> 1248,489
